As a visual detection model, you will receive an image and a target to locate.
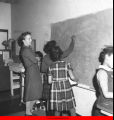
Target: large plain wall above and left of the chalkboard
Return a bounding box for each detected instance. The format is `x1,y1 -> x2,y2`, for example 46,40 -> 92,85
12,0 -> 113,51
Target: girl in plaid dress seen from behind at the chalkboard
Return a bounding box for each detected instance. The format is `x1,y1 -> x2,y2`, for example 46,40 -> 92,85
48,46 -> 76,116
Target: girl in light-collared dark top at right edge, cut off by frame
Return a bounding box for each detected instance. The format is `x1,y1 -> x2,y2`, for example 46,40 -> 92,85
94,46 -> 113,116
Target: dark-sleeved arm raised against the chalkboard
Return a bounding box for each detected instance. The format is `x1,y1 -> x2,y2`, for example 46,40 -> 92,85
61,35 -> 76,59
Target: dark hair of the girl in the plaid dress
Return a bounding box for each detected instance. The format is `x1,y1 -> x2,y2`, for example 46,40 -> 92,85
49,46 -> 63,62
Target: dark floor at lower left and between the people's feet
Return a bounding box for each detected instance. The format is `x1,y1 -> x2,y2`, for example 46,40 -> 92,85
0,90 -> 77,116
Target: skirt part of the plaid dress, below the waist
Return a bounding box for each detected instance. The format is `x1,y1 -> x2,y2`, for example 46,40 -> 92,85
50,80 -> 76,112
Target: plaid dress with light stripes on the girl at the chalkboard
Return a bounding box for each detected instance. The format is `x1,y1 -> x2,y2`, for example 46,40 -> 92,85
49,61 -> 76,112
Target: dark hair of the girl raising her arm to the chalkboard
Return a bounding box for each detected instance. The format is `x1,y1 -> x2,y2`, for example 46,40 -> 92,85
43,40 -> 56,54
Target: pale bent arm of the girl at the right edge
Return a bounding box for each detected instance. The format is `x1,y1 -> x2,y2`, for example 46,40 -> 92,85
97,70 -> 113,98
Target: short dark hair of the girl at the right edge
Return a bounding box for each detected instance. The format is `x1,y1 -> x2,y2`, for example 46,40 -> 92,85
99,46 -> 113,64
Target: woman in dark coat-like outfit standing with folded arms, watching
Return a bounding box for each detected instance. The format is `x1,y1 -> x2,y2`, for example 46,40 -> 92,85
18,32 -> 43,115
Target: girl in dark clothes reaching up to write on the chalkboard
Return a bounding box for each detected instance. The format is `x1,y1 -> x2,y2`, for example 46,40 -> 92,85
41,35 -> 76,106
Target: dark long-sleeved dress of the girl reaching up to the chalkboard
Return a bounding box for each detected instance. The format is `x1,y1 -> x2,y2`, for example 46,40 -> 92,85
41,40 -> 75,101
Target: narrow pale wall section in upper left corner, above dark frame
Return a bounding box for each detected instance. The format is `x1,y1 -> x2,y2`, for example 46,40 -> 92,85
0,2 -> 11,38
